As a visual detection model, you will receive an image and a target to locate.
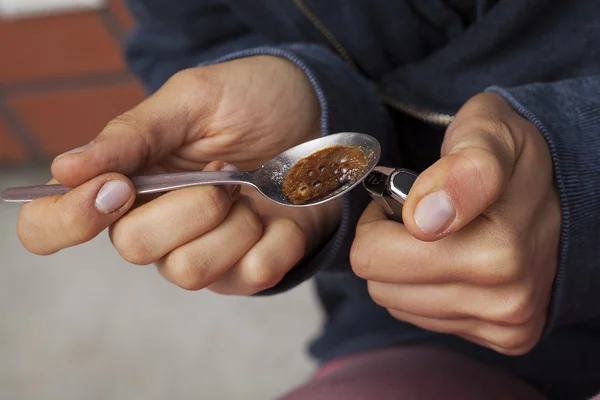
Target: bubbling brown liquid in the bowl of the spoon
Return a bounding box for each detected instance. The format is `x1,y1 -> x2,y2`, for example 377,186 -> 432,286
283,146 -> 367,205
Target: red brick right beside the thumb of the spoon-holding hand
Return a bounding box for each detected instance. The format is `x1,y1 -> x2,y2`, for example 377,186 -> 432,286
9,83 -> 144,157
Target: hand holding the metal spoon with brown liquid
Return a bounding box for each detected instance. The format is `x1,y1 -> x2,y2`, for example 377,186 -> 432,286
18,56 -> 341,294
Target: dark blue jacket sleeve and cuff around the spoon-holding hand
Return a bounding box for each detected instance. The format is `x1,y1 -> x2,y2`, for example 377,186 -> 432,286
127,0 -> 399,295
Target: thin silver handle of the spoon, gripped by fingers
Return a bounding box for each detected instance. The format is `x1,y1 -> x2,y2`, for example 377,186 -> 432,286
0,171 -> 252,203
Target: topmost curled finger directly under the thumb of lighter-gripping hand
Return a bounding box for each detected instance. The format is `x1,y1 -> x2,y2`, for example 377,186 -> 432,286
350,218 -> 527,286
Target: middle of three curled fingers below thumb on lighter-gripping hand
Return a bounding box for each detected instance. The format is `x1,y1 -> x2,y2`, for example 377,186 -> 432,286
368,281 -> 545,326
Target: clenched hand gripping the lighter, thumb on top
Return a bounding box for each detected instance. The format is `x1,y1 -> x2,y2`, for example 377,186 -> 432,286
351,93 -> 561,355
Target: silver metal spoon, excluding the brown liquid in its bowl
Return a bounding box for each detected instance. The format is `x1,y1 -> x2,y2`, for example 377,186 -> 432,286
0,132 -> 381,207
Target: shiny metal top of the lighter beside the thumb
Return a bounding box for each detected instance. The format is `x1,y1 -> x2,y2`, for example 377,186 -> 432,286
362,167 -> 418,222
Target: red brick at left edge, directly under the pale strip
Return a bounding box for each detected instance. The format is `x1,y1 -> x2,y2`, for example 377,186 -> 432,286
0,12 -> 125,83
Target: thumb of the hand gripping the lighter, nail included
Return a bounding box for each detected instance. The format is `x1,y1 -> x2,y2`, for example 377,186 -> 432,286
403,93 -> 523,241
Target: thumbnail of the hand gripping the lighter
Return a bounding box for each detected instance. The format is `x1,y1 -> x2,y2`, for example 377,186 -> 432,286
414,190 -> 456,235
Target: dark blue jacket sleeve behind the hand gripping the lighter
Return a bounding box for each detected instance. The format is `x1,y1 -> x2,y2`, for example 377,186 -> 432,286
488,75 -> 600,334
